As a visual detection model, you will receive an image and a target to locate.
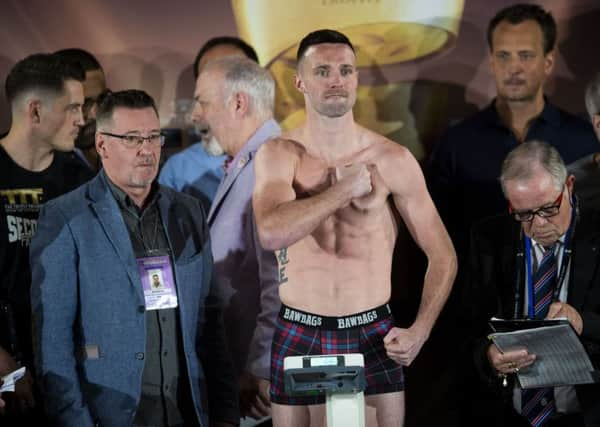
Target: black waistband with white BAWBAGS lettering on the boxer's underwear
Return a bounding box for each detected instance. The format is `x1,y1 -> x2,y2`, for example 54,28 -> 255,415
279,304 -> 392,330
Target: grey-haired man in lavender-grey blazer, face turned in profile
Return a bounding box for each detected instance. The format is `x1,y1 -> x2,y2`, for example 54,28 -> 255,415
192,57 -> 280,418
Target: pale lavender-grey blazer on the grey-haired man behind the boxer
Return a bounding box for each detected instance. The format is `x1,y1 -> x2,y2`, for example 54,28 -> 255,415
208,120 -> 281,379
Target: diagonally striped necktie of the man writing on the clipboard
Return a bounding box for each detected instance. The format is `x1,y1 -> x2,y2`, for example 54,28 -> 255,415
521,246 -> 558,427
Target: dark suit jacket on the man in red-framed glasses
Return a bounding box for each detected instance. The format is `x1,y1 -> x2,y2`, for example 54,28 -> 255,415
465,210 -> 600,426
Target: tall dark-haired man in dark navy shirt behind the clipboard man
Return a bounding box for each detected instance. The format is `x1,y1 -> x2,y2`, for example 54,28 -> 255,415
430,4 -> 597,256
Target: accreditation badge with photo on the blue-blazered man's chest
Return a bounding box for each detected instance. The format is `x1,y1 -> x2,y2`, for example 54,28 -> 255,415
137,255 -> 177,310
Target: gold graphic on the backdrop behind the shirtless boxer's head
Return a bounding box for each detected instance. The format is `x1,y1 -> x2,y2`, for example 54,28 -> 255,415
232,0 -> 464,158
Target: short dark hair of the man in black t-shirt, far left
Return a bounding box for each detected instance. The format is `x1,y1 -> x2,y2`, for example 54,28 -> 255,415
4,53 -> 85,105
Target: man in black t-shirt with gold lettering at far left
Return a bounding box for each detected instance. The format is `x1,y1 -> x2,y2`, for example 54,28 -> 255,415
0,54 -> 91,425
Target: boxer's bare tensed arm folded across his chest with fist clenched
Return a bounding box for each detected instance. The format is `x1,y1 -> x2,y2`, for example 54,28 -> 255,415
252,139 -> 371,250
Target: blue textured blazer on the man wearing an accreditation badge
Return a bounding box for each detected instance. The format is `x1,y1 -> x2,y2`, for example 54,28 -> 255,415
30,172 -> 239,427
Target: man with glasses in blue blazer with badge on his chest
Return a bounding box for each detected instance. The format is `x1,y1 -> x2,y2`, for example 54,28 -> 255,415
30,90 -> 239,427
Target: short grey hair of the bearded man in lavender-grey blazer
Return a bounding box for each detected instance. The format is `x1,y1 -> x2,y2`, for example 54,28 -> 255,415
202,56 -> 275,118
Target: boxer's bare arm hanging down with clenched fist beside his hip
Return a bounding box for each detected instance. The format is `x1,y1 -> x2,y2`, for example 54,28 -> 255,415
381,146 -> 457,364
